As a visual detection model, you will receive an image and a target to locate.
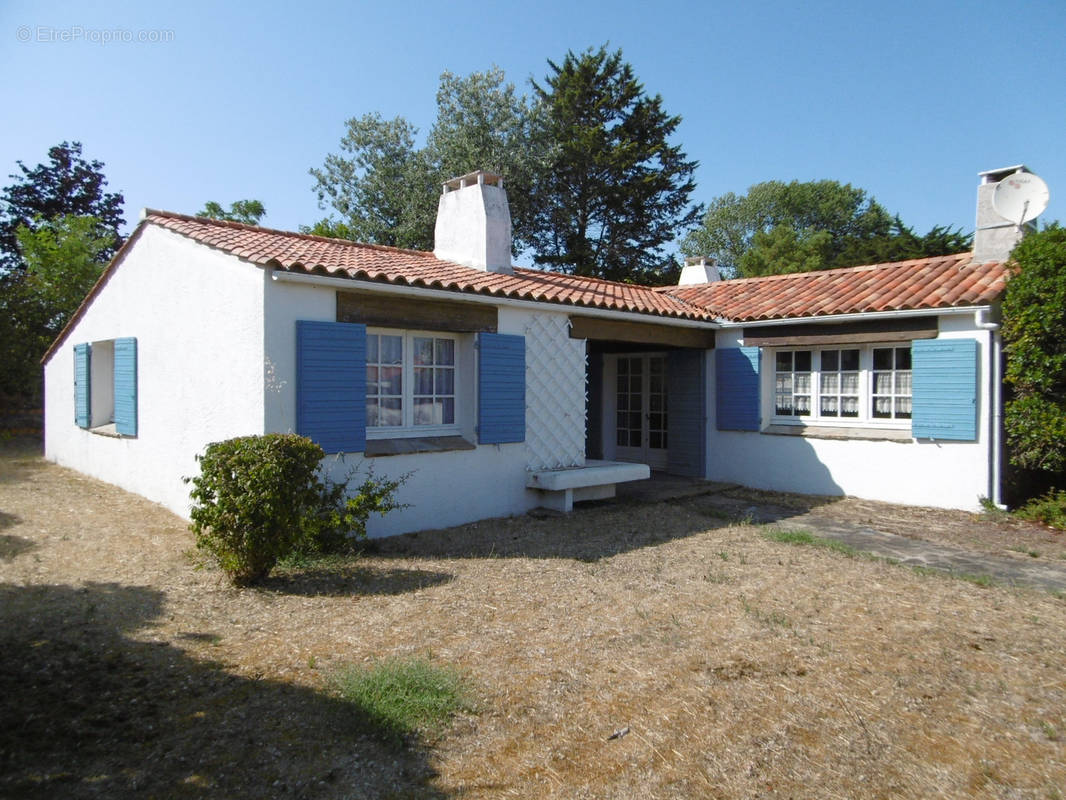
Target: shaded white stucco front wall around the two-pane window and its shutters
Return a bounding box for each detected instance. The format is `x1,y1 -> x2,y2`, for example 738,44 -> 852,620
265,281 -> 584,537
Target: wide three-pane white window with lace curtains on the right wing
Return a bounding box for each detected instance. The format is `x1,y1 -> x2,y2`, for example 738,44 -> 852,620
774,345 -> 911,425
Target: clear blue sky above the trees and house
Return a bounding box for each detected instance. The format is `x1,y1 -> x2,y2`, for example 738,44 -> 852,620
0,0 -> 1066,263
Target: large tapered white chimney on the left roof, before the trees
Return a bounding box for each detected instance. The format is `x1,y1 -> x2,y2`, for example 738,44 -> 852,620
433,170 -> 513,274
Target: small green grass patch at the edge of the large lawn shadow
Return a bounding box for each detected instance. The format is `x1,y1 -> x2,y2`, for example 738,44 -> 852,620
333,658 -> 473,746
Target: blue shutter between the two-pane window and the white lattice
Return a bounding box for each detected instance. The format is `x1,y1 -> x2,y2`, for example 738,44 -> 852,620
478,333 -> 526,445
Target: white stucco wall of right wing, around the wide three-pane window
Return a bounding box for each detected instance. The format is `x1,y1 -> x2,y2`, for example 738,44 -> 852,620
707,315 -> 991,510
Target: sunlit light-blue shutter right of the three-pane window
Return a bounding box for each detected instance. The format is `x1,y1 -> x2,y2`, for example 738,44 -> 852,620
910,339 -> 978,442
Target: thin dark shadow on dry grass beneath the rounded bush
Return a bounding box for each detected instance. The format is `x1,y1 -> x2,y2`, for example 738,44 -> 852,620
263,560 -> 455,597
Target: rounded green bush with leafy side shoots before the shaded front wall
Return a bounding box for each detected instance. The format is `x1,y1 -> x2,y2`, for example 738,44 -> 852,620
185,433 -> 404,585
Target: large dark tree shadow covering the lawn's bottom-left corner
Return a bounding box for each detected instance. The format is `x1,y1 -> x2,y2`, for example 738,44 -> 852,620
0,583 -> 445,798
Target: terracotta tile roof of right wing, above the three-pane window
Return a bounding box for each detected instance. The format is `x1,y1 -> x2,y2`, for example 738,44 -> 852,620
656,253 -> 1007,322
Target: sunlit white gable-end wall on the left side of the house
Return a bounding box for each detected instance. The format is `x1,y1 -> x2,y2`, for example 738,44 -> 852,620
45,225 -> 265,517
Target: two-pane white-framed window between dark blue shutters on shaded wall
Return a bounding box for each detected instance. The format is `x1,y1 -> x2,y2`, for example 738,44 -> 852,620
367,329 -> 458,435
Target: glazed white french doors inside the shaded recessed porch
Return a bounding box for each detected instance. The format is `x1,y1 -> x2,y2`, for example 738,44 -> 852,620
614,355 -> 668,469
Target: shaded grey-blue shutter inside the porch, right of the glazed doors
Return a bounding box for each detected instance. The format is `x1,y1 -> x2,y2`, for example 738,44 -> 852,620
666,350 -> 707,478
